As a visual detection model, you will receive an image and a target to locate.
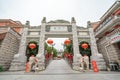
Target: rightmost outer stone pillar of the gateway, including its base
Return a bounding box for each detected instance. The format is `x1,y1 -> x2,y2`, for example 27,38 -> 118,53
88,22 -> 106,70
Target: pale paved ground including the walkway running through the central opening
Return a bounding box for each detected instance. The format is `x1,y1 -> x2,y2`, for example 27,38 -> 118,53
0,60 -> 120,80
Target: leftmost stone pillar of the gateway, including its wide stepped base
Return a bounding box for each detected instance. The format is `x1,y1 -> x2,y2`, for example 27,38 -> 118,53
9,28 -> 28,71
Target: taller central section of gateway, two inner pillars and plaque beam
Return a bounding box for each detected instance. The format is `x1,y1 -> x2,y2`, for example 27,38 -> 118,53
37,18 -> 81,69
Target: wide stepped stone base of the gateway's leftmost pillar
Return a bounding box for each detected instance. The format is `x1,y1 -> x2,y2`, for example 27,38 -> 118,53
9,54 -> 26,71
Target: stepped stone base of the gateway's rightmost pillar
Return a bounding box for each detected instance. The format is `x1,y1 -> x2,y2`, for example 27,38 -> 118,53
91,54 -> 106,71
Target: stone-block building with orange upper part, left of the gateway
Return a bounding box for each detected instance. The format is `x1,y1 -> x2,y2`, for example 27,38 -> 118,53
0,19 -> 23,70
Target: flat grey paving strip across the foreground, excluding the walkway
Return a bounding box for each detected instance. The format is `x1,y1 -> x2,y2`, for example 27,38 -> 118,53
0,73 -> 120,80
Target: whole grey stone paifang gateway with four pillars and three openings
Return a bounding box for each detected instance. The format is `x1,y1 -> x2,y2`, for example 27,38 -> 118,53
6,17 -> 106,71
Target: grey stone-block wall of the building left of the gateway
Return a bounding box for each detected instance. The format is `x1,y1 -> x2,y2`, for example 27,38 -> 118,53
0,28 -> 20,70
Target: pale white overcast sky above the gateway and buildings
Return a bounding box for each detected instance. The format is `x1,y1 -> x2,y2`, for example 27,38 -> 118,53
0,0 -> 116,49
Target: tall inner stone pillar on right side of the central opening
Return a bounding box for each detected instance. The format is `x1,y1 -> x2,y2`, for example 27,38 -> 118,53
71,18 -> 82,70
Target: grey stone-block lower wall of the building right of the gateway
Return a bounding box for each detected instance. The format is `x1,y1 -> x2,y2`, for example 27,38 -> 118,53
97,29 -> 120,65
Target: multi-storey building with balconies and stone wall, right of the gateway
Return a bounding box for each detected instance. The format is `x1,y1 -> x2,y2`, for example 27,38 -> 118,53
94,0 -> 120,65
